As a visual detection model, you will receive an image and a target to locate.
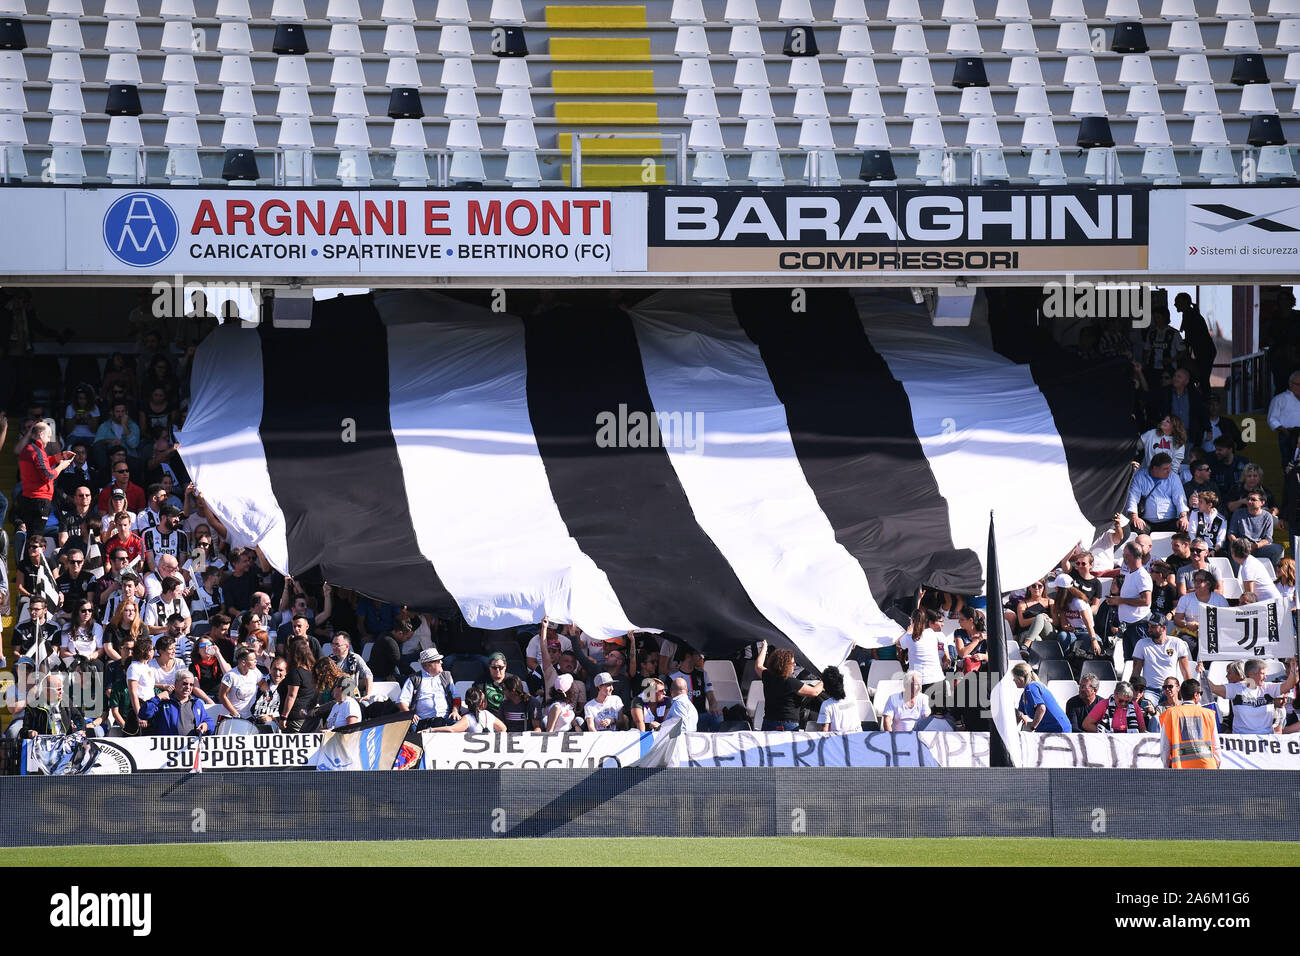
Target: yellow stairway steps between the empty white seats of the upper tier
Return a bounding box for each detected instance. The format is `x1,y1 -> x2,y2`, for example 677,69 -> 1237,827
546,4 -> 666,186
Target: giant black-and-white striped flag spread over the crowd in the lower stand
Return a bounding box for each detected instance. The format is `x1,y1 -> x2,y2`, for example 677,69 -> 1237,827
181,290 -> 1131,666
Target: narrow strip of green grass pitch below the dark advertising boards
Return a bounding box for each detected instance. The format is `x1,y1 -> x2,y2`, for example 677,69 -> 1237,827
0,836 -> 1300,866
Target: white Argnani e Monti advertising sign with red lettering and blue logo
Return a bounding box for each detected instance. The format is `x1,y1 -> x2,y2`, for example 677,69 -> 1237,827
61,189 -> 645,277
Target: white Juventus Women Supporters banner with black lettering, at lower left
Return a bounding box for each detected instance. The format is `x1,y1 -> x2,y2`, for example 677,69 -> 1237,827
22,734 -> 333,774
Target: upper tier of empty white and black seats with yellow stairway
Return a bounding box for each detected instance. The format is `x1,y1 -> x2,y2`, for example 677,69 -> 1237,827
0,0 -> 1300,187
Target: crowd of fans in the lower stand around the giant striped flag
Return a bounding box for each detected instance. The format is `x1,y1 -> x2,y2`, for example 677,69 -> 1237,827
0,295 -> 1300,770
